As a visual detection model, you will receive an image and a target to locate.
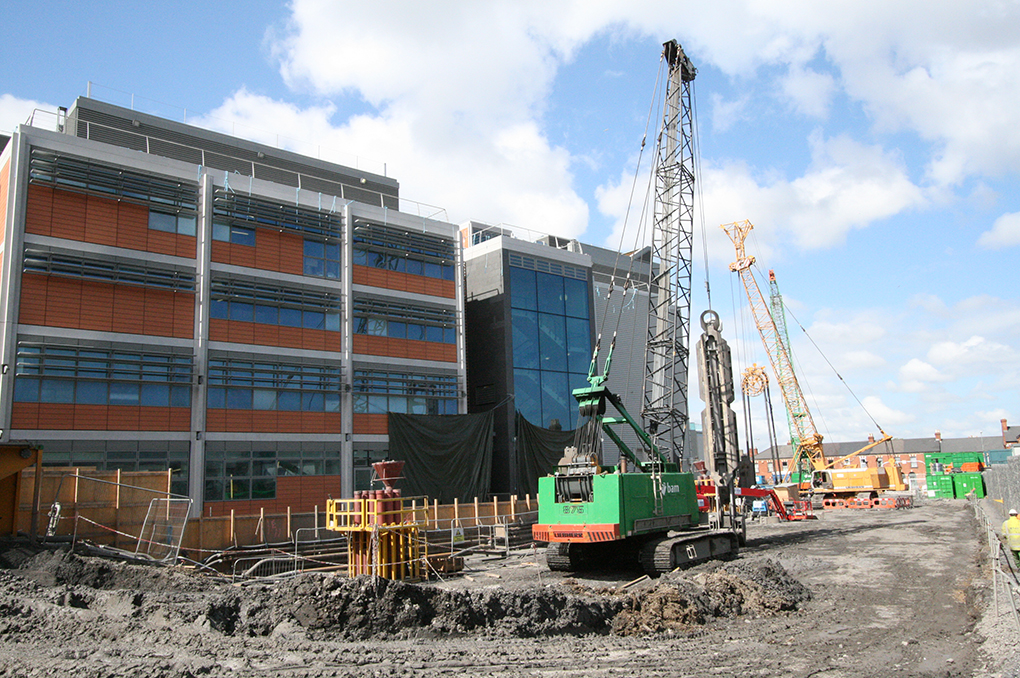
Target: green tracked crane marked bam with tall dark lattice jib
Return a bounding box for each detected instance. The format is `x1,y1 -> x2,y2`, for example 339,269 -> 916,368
532,41 -> 740,575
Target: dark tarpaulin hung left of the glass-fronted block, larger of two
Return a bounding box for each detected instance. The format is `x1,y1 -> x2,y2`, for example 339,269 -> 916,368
389,412 -> 493,504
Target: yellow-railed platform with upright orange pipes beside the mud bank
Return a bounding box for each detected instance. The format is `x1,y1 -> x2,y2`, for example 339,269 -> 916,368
325,461 -> 428,581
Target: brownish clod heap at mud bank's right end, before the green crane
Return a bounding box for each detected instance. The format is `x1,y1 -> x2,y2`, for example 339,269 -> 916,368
612,559 -> 811,635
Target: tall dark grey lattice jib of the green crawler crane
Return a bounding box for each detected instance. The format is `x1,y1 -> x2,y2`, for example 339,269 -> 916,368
642,41 -> 697,462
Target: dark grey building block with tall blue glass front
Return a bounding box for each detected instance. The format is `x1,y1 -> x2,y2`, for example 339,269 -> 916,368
462,222 -> 595,493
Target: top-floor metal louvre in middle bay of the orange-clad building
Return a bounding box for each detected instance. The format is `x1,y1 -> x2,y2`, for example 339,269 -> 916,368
213,189 -> 342,239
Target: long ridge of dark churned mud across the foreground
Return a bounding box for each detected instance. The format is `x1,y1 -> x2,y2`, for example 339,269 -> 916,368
0,551 -> 810,640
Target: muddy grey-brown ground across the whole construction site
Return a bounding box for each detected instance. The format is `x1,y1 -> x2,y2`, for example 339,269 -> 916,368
0,501 -> 1020,678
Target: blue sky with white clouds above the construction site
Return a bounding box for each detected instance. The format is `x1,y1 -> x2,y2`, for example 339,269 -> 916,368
0,0 -> 1020,448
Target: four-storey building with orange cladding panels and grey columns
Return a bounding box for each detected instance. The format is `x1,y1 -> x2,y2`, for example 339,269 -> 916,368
0,98 -> 465,515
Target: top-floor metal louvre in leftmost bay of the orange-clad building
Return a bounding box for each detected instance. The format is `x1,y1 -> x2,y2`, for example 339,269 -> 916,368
29,148 -> 198,213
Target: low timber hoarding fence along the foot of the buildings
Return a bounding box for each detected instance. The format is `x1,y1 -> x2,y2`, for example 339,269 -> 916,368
17,467 -> 538,569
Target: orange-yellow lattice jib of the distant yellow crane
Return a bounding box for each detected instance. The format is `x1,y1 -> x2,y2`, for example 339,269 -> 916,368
722,221 -> 825,469
